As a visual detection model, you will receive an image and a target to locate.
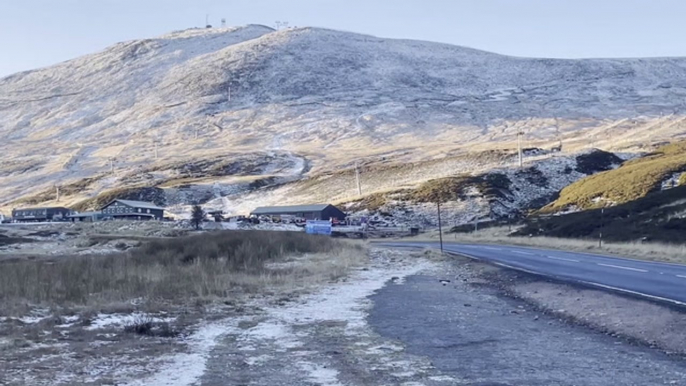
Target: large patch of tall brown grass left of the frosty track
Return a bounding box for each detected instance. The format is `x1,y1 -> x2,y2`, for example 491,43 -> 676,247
0,231 -> 366,307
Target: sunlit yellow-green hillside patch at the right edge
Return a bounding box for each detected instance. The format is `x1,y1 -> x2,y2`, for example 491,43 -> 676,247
542,141 -> 686,212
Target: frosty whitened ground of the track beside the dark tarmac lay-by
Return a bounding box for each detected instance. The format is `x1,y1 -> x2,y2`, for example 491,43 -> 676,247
123,251 -> 444,386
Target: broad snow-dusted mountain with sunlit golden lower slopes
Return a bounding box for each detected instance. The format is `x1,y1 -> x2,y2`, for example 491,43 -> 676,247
0,25 -> 686,214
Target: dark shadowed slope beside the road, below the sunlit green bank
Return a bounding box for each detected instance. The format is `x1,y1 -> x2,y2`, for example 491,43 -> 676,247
517,186 -> 686,243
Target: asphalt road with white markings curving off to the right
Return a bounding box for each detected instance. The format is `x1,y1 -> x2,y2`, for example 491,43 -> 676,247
383,242 -> 686,305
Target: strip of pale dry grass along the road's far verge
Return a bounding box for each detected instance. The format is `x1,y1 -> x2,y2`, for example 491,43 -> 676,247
408,227 -> 686,264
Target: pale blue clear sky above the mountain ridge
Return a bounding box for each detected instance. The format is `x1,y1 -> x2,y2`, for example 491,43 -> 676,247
0,0 -> 686,76
